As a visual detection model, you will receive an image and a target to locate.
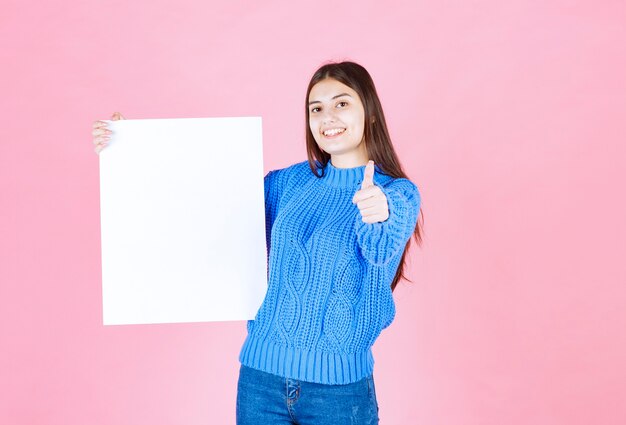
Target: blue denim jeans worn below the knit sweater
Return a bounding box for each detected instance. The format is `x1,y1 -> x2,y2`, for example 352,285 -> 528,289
237,365 -> 378,425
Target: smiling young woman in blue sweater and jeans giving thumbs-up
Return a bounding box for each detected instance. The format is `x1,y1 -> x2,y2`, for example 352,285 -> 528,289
93,62 -> 421,425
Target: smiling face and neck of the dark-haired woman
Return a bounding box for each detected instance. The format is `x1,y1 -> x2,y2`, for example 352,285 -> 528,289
309,78 -> 368,168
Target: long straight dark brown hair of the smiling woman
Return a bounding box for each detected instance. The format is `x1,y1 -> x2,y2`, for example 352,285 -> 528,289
304,62 -> 424,291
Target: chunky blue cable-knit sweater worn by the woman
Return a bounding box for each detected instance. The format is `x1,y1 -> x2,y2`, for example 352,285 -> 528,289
239,161 -> 420,384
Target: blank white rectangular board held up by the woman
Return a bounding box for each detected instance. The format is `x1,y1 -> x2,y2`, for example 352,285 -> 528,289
100,117 -> 267,325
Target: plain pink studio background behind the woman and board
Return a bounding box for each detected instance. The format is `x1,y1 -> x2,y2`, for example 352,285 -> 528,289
0,0 -> 626,425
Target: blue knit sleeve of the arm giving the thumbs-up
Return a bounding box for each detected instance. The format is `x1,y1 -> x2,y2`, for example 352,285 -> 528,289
355,179 -> 421,265
